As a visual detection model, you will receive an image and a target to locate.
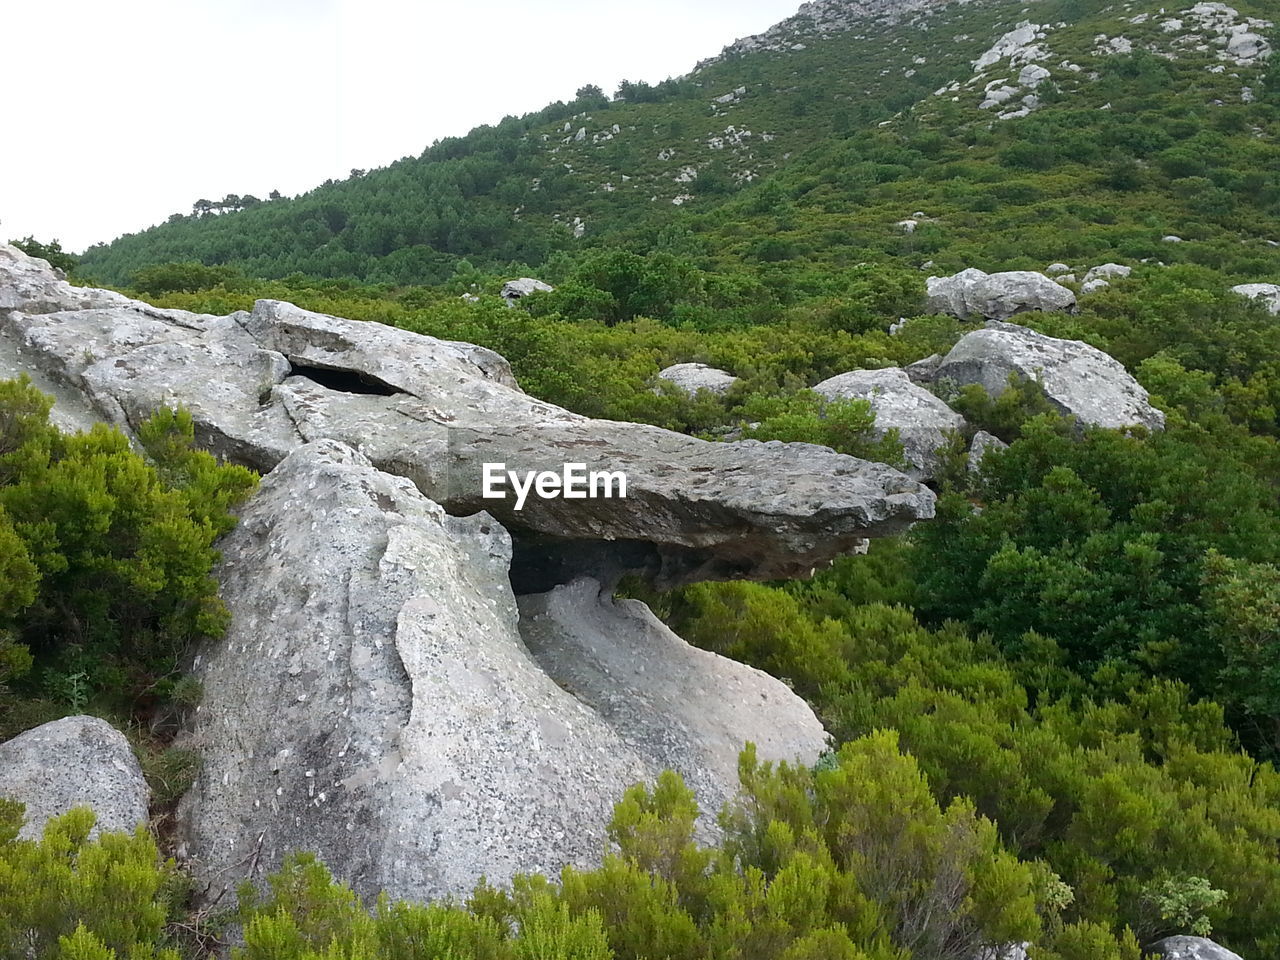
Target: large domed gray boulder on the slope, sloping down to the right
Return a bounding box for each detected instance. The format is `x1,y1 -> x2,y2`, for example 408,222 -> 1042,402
934,323 -> 1165,430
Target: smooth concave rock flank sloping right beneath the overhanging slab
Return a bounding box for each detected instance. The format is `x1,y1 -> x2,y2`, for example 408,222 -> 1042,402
520,579 -> 827,840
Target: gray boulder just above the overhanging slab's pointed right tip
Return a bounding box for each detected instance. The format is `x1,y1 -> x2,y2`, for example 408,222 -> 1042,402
813,367 -> 965,480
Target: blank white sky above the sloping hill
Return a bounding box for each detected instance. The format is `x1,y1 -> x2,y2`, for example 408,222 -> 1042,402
0,0 -> 799,251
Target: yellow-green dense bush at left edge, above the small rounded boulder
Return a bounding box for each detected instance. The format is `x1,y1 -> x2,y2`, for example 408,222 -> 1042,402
0,379 -> 256,728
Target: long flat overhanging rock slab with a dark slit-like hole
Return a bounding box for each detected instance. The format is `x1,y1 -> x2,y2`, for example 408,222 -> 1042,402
0,245 -> 933,591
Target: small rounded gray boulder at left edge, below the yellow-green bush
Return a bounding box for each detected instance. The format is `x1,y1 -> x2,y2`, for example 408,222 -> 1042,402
0,717 -> 151,840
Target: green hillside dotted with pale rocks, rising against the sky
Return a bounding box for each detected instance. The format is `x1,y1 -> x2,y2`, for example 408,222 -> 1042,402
81,0 -> 1280,284
